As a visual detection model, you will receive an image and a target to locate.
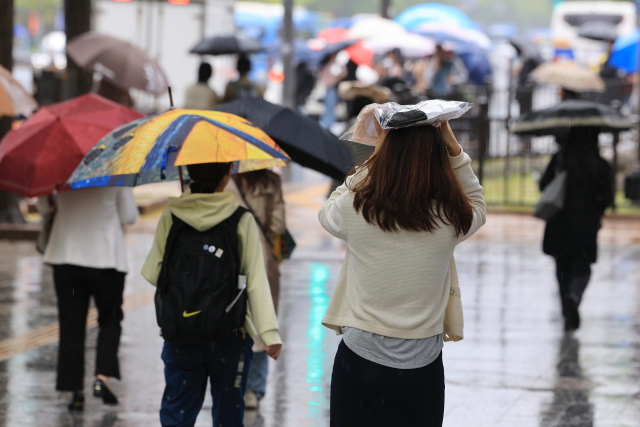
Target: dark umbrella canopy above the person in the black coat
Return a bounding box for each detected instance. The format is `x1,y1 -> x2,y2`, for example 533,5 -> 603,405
512,100 -> 635,136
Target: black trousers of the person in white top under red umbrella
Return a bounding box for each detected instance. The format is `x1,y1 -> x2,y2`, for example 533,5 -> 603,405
53,264 -> 125,391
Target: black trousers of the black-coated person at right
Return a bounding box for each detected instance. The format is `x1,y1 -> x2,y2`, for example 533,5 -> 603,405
555,255 -> 591,317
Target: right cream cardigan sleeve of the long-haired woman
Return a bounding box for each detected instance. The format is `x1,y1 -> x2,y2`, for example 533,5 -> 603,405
449,151 -> 487,242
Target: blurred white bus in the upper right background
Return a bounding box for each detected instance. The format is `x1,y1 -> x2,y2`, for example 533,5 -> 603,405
551,1 -> 637,66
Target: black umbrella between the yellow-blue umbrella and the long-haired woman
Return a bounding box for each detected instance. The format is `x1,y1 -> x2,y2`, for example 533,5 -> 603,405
214,98 -> 353,179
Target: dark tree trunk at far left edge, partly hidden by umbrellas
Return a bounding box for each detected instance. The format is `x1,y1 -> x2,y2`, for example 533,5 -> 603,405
0,0 -> 25,223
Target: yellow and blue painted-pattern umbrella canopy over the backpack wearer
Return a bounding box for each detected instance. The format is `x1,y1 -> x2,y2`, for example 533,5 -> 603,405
68,110 -> 289,189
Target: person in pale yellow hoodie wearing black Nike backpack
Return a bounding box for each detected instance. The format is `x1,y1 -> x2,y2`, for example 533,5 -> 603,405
142,163 -> 282,427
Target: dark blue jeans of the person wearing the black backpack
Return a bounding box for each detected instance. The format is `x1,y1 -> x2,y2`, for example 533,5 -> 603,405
160,331 -> 253,427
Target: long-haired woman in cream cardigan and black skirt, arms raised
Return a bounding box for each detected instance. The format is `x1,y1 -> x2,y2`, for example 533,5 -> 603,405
318,121 -> 486,427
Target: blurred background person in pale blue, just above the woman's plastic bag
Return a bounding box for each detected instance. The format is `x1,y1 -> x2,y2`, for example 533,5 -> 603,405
423,44 -> 469,98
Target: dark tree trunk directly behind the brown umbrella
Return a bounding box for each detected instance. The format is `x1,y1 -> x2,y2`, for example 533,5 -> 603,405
65,0 -> 93,97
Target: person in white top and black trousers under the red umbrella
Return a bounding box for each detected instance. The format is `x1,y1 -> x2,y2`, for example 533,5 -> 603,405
44,187 -> 138,411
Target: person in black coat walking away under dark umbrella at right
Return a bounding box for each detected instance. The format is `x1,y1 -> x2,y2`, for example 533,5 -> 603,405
540,127 -> 614,331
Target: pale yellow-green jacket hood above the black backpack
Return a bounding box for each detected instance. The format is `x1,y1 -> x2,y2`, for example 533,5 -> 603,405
168,191 -> 238,231
